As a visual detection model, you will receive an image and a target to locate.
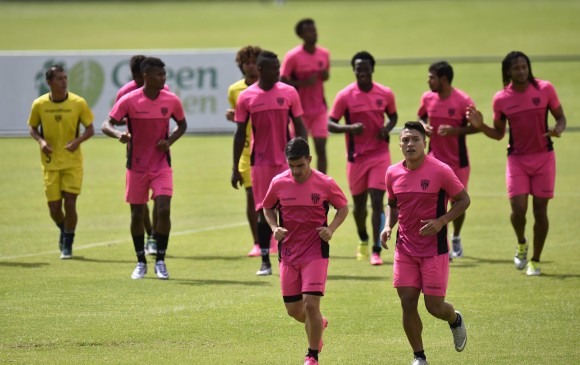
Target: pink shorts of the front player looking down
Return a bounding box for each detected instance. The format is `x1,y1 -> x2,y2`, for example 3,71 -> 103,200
279,259 -> 328,298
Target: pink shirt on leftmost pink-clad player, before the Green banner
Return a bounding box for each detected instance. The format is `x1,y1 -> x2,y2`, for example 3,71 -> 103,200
109,88 -> 185,172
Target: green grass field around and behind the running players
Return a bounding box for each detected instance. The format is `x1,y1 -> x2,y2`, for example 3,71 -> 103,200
0,0 -> 580,365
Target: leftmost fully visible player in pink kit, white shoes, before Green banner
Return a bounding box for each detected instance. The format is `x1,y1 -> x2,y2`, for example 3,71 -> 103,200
102,57 -> 187,280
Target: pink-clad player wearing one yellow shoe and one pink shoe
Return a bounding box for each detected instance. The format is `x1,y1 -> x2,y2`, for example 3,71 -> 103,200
328,52 -> 398,265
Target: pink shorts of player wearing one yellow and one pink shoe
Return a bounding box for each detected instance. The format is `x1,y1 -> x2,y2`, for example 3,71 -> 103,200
346,155 -> 391,195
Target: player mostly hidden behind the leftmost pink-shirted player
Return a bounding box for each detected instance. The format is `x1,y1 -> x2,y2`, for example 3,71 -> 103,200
115,55 -> 169,255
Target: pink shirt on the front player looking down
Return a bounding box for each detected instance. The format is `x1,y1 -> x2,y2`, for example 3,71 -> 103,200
262,169 -> 348,265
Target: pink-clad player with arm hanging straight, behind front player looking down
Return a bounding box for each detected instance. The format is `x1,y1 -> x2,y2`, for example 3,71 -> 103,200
231,51 -> 306,276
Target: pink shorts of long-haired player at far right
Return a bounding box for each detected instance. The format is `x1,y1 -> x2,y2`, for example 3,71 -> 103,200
506,151 -> 556,198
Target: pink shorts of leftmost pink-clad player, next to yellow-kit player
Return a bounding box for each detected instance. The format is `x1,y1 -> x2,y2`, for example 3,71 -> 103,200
125,168 -> 173,204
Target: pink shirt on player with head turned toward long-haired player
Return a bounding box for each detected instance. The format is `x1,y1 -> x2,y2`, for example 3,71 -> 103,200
417,88 -> 475,170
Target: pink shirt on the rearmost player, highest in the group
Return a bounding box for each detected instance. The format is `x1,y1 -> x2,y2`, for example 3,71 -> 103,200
280,45 -> 330,115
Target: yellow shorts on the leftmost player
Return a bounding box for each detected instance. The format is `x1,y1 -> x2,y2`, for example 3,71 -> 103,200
43,166 -> 83,202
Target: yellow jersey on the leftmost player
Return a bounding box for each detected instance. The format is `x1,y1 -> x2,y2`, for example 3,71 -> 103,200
28,91 -> 94,170
